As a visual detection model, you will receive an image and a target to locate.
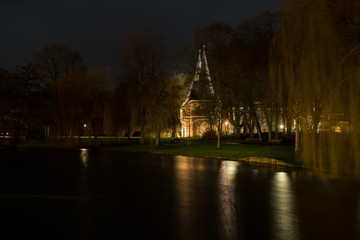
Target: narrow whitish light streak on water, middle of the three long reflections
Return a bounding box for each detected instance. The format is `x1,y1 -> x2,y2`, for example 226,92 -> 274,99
218,161 -> 240,239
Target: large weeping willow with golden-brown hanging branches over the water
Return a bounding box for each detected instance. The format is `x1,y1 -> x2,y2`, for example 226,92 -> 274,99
269,0 -> 360,177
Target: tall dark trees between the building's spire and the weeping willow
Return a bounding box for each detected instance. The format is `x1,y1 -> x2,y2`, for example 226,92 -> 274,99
191,12 -> 280,142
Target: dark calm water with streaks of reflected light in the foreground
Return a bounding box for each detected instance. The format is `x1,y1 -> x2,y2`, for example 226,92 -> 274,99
0,149 -> 360,240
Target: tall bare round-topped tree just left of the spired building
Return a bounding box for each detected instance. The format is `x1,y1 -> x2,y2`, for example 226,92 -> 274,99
119,31 -> 168,144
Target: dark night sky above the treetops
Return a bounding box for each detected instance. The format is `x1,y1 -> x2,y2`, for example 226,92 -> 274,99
0,0 -> 281,68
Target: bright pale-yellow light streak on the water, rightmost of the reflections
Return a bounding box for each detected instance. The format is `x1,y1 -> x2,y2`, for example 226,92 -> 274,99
271,172 -> 300,239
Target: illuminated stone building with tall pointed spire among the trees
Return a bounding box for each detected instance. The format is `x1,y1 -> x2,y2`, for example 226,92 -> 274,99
180,46 -> 215,137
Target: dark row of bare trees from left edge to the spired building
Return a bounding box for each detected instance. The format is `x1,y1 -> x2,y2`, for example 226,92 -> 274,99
0,38 -> 184,148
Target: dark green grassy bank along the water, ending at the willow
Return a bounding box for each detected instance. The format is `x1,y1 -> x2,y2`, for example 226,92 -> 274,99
16,138 -> 299,165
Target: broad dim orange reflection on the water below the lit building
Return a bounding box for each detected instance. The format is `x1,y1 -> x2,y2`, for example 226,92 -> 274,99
173,156 -> 224,239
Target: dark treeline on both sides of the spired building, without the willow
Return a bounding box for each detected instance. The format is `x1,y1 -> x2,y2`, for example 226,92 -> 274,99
0,12 -> 278,150
